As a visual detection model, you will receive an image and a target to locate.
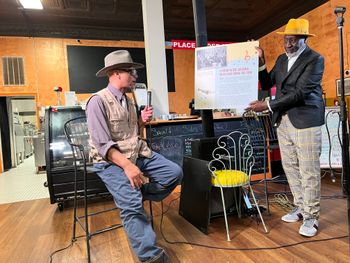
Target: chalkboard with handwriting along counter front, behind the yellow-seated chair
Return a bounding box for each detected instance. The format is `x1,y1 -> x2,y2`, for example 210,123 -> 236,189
146,118 -> 268,174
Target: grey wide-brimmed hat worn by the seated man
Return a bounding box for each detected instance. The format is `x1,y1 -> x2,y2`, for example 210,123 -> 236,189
96,50 -> 144,77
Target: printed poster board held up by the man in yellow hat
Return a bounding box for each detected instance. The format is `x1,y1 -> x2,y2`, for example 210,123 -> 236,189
195,41 -> 259,114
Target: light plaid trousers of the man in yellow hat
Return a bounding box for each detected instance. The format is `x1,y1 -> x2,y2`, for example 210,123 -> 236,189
277,114 -> 321,219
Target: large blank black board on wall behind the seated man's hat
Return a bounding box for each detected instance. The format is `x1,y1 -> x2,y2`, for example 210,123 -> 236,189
67,45 -> 175,93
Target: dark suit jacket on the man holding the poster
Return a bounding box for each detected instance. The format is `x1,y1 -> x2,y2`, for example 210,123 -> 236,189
259,47 -> 325,129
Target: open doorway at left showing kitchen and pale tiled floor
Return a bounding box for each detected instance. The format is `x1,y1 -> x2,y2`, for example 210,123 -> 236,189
0,95 -> 49,204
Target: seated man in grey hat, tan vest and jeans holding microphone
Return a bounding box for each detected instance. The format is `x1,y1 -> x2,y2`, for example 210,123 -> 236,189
86,50 -> 182,262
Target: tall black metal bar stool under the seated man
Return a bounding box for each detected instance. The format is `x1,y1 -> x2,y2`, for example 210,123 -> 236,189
64,116 -> 122,262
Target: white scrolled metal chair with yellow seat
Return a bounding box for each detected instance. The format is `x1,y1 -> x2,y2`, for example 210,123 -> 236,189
208,131 -> 268,241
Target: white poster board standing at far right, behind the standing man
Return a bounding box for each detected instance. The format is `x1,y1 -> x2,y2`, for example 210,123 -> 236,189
320,107 -> 342,168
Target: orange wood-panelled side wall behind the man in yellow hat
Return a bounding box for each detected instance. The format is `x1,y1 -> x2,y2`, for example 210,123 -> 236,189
260,0 -> 350,101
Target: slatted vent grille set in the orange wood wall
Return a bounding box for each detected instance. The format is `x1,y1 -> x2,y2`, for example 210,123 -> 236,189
2,57 -> 24,86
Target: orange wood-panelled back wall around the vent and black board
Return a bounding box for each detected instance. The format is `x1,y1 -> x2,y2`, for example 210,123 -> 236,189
0,37 -> 194,113
